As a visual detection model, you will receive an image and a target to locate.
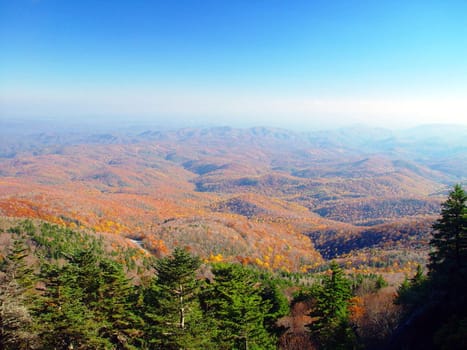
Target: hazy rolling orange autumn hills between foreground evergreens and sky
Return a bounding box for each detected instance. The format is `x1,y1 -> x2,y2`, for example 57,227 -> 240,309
0,126 -> 467,269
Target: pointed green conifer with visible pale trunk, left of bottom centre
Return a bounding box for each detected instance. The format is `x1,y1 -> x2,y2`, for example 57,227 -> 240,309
144,248 -> 210,350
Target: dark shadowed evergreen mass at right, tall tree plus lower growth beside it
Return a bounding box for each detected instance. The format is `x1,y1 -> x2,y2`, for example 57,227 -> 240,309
392,185 -> 467,349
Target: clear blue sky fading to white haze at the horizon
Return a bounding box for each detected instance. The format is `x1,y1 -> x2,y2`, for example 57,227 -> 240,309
0,0 -> 467,128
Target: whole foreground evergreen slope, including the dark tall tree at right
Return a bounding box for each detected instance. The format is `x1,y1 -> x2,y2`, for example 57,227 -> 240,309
0,185 -> 467,350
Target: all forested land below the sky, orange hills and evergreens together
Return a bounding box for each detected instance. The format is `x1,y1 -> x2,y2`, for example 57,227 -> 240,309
0,124 -> 467,350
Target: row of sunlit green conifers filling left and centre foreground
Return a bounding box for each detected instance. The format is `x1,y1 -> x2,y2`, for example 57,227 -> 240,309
0,222 -> 288,350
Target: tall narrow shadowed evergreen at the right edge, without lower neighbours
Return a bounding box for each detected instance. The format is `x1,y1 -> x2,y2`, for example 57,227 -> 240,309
429,185 -> 467,349
